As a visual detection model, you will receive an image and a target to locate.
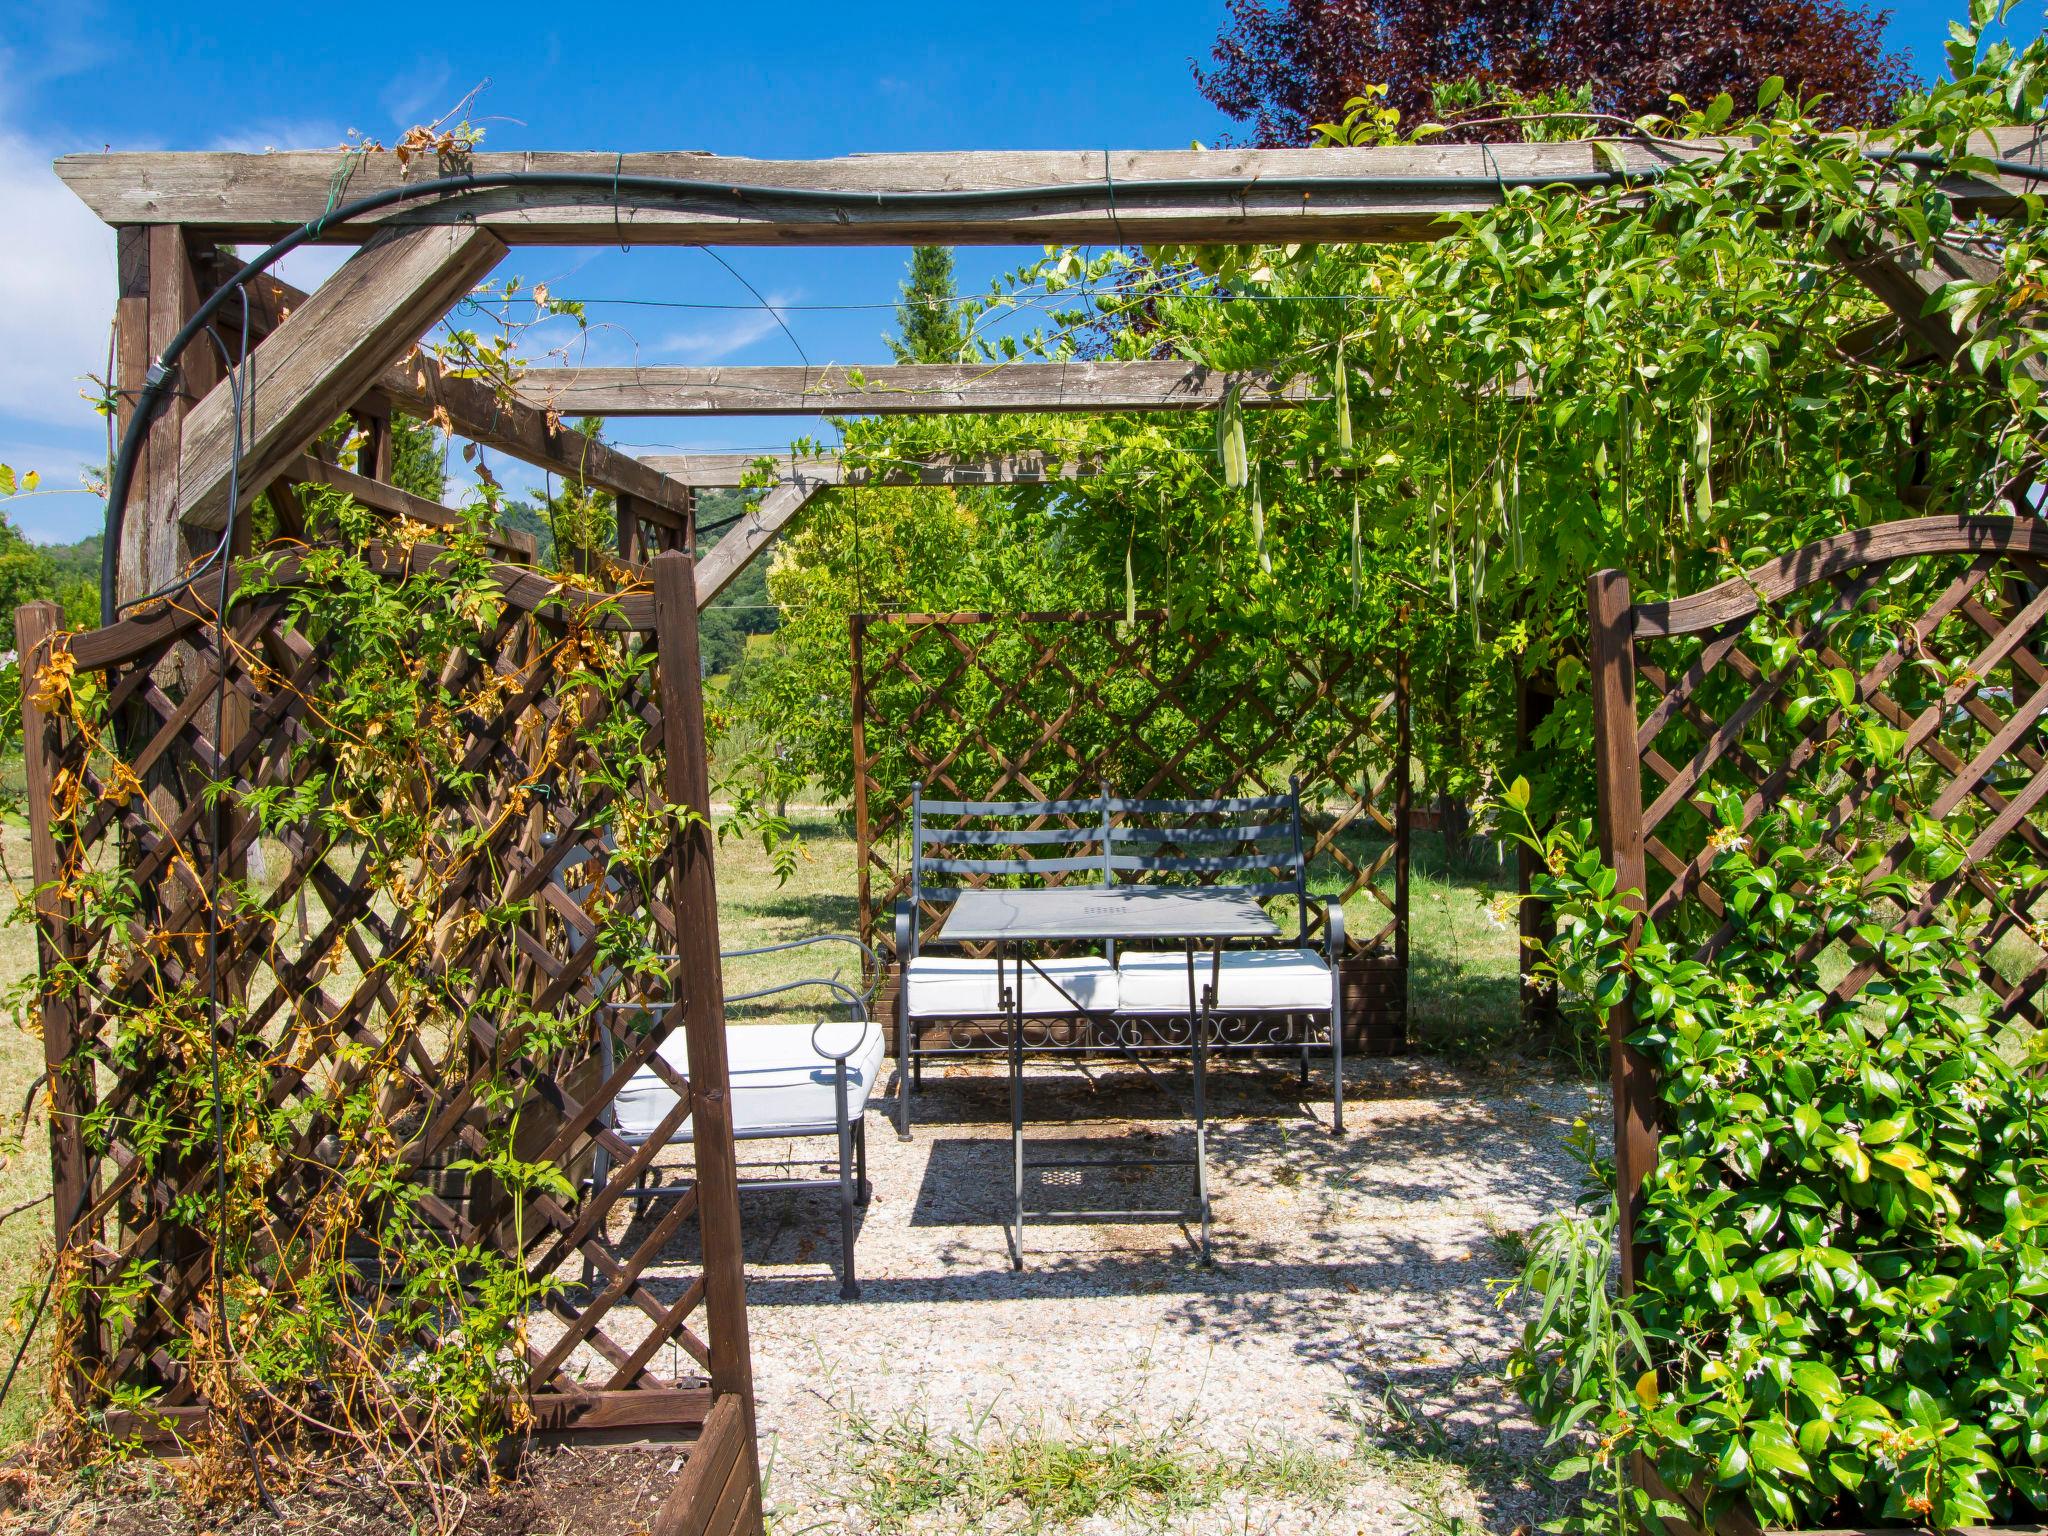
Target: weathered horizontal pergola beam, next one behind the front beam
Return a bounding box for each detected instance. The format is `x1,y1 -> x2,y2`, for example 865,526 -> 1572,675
518,360 -> 1311,416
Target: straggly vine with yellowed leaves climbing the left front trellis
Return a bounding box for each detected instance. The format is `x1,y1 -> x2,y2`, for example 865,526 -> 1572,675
12,494 -> 690,1518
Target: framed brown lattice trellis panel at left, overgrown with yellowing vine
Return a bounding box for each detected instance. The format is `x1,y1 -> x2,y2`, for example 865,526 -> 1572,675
18,551 -> 754,1479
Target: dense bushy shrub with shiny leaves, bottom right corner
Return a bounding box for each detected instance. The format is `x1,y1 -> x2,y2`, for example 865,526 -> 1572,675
1507,784 -> 2048,1528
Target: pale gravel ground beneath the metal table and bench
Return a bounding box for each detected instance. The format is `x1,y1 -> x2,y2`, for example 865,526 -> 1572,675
704,1059 -> 1604,1536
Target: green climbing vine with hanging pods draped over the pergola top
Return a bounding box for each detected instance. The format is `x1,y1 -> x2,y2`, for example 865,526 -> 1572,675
733,2 -> 2048,843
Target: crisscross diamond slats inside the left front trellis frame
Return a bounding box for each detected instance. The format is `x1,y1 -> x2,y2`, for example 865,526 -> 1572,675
31,573 -> 741,1423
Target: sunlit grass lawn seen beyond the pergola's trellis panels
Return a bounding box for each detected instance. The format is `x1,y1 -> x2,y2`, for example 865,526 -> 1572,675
0,811 -> 1516,1444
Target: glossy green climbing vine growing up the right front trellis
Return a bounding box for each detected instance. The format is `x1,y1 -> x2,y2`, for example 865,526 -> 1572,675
1499,561 -> 2048,1530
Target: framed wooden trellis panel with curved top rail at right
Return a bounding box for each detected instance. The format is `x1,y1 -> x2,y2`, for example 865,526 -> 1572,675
1589,518 -> 2048,1274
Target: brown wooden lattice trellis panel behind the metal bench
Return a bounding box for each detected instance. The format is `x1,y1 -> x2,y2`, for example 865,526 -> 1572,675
852,610 -> 1409,1028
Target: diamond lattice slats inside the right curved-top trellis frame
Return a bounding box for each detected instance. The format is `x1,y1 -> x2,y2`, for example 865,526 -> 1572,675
1636,553 -> 2048,1028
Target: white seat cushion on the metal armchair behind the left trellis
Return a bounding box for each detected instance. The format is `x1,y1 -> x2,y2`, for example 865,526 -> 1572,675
612,1020 -> 883,1143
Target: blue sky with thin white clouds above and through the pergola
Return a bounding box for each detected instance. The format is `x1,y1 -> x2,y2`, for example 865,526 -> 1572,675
0,0 -> 2015,539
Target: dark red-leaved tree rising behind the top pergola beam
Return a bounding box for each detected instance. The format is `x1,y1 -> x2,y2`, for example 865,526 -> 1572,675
1194,0 -> 1913,145
